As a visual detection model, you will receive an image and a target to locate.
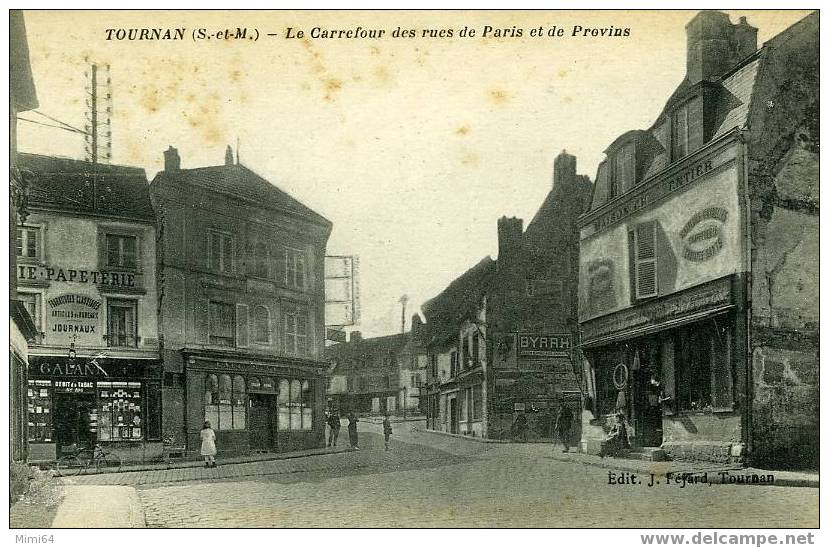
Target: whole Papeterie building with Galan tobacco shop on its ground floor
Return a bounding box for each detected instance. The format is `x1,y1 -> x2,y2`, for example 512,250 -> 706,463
15,153 -> 162,461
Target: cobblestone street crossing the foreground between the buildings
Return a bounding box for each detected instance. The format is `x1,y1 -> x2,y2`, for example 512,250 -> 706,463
64,423 -> 818,527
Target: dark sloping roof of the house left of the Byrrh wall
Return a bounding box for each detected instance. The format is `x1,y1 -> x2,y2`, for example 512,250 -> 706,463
421,256 -> 496,346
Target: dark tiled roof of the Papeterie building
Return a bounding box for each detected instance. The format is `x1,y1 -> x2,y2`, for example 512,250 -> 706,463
18,153 -> 155,223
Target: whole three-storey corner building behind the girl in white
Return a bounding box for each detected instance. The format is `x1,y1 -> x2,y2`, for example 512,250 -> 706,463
151,147 -> 331,454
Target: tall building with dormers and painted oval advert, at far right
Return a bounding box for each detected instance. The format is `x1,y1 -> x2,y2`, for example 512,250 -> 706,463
579,11 -> 819,466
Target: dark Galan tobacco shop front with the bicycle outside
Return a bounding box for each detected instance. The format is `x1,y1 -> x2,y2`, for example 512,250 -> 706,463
27,356 -> 162,462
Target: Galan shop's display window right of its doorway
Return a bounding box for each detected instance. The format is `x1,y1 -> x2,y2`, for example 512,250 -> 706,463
96,381 -> 145,441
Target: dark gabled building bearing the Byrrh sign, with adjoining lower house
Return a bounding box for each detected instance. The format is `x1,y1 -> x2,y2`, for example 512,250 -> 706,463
423,152 -> 592,440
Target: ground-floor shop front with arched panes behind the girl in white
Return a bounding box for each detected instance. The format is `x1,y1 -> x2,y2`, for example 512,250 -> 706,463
186,359 -> 325,455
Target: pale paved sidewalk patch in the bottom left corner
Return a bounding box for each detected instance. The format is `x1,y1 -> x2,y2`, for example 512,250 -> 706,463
52,485 -> 146,529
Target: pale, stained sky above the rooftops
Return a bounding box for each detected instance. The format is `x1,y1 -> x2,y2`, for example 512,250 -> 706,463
18,10 -> 807,336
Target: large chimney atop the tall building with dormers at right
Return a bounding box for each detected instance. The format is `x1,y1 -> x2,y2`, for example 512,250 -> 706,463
685,10 -> 735,84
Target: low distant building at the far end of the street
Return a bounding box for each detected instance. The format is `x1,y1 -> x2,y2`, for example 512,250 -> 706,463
326,315 -> 426,415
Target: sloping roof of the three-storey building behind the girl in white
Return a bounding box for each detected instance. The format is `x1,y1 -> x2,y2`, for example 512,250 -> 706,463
152,164 -> 331,227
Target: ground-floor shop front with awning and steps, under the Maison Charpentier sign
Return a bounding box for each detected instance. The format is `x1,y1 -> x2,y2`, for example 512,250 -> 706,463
583,277 -> 745,462
